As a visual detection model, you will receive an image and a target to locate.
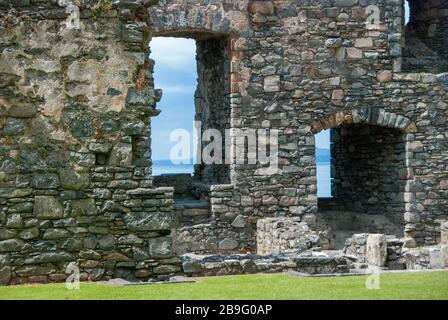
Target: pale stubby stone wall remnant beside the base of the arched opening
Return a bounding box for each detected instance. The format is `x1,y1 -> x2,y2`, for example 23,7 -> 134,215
257,217 -> 329,255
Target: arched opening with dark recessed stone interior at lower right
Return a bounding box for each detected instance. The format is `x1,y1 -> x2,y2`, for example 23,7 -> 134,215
315,110 -> 414,249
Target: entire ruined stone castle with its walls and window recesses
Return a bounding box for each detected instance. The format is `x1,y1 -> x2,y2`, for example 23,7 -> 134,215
0,0 -> 448,284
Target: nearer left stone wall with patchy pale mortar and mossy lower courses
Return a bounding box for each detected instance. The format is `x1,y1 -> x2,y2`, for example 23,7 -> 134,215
0,1 -> 180,284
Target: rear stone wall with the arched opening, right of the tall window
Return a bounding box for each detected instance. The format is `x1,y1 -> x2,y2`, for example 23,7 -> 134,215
149,0 -> 447,252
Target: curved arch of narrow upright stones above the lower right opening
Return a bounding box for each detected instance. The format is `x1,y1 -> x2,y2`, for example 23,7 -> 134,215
311,108 -> 417,134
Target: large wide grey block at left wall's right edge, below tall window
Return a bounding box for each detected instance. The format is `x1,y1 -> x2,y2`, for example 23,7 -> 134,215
124,212 -> 176,231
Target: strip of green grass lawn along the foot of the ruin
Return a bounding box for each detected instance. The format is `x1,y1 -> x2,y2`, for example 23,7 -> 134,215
0,272 -> 448,300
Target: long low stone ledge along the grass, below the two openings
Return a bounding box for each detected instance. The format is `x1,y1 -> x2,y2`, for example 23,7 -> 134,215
181,252 -> 351,276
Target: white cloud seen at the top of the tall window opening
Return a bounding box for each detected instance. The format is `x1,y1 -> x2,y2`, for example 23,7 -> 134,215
150,37 -> 196,72
